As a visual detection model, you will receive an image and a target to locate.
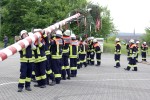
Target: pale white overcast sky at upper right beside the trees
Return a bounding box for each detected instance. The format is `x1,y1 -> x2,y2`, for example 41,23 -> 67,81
89,0 -> 150,33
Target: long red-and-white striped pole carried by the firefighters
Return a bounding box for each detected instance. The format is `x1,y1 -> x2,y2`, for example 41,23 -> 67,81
0,13 -> 80,61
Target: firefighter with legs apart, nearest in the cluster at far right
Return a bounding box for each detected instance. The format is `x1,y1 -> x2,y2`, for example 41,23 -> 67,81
124,39 -> 138,71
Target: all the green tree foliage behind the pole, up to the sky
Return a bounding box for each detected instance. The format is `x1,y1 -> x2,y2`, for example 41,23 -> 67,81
0,0 -> 114,43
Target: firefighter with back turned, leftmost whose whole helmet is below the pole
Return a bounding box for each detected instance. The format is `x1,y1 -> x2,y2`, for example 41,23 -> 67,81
50,30 -> 64,84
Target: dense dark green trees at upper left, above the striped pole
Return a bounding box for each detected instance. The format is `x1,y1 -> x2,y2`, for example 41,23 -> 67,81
1,0 -> 86,42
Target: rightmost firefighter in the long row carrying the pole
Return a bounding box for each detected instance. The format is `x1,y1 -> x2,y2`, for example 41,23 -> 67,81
93,39 -> 101,66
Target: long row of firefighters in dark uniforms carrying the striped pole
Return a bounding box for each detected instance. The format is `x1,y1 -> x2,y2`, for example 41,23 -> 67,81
18,29 -> 101,92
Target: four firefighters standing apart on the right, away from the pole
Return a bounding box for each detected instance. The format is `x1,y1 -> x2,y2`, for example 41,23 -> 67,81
114,38 -> 148,71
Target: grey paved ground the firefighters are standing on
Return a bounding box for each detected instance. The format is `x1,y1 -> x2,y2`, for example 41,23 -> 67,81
0,54 -> 150,100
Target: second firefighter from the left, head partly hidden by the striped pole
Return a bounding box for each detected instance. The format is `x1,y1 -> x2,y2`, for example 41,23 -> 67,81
34,29 -> 47,88
